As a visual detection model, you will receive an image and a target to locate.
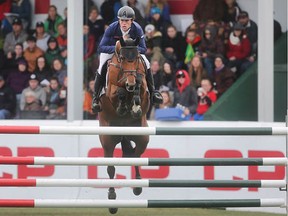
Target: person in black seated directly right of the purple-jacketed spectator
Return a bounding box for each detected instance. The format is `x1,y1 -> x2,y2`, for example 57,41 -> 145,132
34,56 -> 52,87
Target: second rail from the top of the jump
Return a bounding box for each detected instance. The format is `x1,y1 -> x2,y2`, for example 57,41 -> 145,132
0,156 -> 287,166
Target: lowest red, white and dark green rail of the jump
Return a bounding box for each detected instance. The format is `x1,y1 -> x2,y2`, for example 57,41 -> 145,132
0,199 -> 285,208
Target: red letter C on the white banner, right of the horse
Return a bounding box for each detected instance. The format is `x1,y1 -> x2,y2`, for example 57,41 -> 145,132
204,150 -> 243,191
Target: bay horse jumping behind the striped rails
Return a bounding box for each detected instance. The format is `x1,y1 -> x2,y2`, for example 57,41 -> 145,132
99,37 -> 150,214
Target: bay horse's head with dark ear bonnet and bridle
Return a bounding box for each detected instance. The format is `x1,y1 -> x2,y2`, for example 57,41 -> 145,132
115,37 -> 142,92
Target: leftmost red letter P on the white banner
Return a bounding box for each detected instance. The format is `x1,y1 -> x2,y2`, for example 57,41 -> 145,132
18,147 -> 54,178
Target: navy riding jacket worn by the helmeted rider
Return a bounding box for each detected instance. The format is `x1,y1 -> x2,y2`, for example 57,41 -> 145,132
98,21 -> 147,54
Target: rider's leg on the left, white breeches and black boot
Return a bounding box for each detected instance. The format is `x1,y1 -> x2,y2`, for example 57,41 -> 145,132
92,53 -> 113,113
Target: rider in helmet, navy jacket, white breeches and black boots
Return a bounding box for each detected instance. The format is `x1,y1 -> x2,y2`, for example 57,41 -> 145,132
92,6 -> 163,112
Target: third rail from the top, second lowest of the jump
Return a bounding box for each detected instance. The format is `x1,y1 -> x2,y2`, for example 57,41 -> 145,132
0,179 -> 286,188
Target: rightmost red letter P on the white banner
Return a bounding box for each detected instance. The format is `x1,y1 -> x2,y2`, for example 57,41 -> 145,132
248,150 -> 285,191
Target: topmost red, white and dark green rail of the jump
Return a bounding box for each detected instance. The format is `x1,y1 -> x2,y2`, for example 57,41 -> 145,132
0,125 -> 288,135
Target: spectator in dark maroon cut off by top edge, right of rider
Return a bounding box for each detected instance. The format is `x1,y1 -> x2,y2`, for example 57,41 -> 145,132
193,0 -> 224,23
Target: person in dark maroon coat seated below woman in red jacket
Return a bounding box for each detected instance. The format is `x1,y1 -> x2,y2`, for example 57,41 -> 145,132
213,55 -> 235,98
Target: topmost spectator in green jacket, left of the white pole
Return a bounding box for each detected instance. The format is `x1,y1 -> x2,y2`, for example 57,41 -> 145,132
44,5 -> 63,37
